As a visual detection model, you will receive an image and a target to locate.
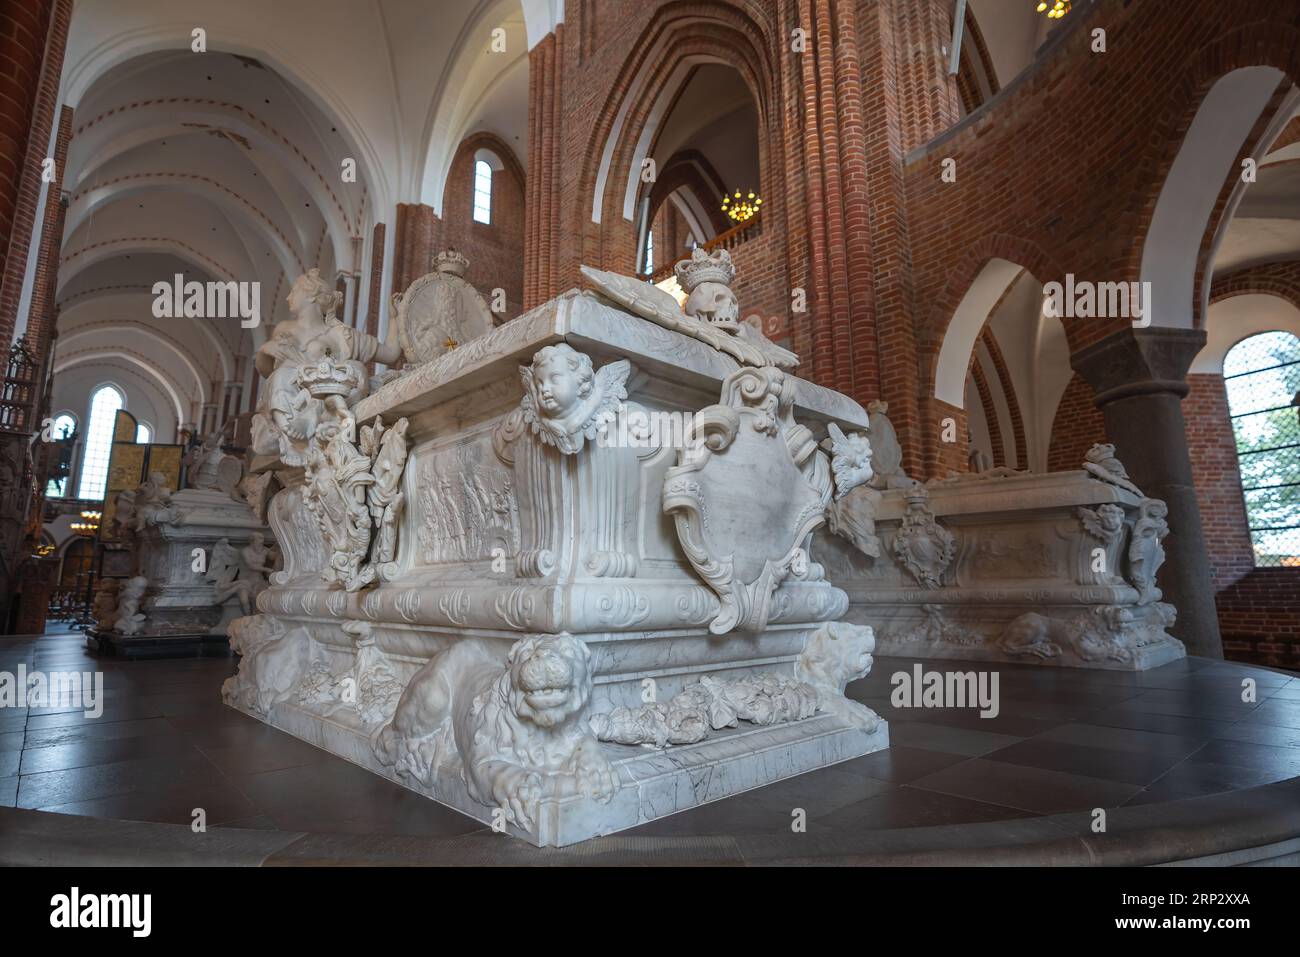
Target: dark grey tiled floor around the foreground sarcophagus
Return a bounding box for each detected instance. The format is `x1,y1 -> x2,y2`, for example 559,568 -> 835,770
0,635 -> 1300,836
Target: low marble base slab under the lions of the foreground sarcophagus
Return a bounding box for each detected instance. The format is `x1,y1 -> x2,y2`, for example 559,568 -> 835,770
231,703 -> 889,846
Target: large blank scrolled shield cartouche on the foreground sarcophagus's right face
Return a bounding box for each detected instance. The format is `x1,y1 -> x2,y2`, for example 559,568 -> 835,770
663,365 -> 826,635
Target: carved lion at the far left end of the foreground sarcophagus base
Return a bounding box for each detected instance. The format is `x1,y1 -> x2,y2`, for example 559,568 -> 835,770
221,615 -> 312,714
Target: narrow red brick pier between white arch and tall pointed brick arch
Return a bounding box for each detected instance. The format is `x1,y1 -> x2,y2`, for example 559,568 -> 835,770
524,26 -> 564,309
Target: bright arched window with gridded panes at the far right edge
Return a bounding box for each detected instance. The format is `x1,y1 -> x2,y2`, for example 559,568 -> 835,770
1223,332 -> 1300,566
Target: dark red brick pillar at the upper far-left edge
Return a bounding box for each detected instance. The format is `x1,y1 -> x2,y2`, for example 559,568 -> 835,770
0,0 -> 72,350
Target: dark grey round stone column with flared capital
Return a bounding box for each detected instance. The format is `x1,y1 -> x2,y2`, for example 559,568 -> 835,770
1070,328 -> 1223,658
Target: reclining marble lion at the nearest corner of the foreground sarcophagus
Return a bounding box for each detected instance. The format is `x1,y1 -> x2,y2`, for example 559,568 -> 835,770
372,633 -> 618,831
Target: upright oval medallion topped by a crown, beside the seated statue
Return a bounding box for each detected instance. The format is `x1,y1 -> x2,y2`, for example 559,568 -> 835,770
393,250 -> 493,365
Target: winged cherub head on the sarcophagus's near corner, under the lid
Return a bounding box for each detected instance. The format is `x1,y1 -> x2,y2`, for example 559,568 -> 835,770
503,342 -> 632,455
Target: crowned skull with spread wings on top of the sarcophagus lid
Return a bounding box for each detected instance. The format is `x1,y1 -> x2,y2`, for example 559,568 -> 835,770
581,261 -> 800,369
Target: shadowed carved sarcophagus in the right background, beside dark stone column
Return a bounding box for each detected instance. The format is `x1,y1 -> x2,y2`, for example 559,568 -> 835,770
814,468 -> 1186,670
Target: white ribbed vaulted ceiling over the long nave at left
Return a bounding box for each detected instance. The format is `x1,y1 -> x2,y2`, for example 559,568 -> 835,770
55,0 -> 535,439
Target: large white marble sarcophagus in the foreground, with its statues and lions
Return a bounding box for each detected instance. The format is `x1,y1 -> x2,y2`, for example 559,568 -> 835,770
224,252 -> 888,845
